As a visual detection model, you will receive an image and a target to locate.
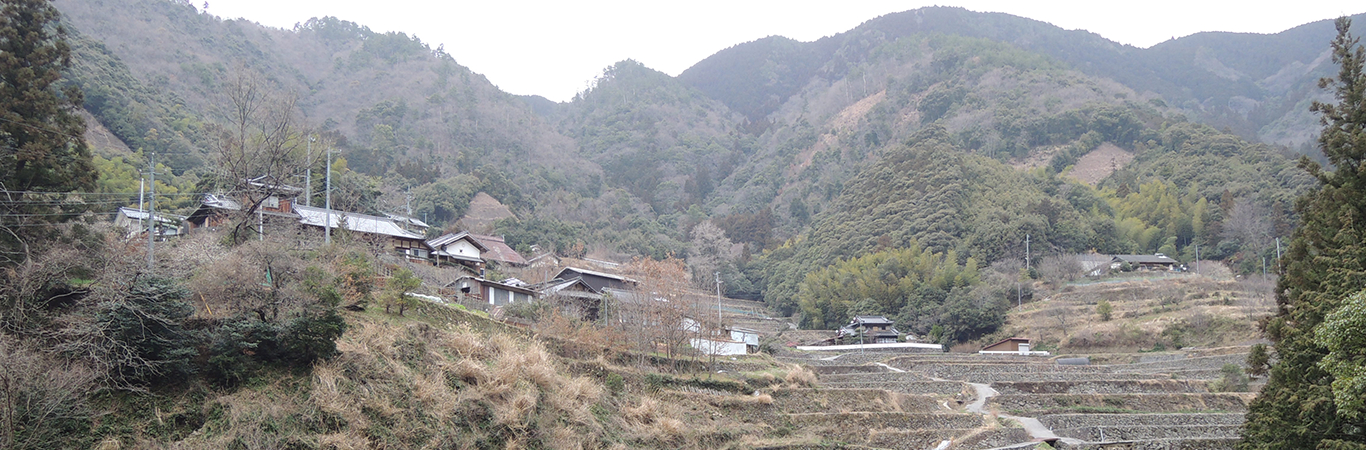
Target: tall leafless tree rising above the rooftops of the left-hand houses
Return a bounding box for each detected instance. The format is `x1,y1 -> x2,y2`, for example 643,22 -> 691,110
210,66 -> 307,243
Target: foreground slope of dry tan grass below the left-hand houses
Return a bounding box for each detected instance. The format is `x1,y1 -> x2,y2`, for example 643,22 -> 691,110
96,298 -> 822,449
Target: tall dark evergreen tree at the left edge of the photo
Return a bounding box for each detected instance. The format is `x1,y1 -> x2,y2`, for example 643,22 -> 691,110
0,0 -> 96,255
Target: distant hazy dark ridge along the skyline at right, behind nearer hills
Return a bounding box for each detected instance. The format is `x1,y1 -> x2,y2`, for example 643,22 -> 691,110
679,7 -> 1361,146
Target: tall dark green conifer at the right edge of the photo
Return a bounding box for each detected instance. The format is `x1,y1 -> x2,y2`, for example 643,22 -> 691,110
1238,18 -> 1366,449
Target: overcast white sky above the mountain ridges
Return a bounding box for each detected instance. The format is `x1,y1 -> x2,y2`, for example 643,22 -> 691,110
207,0 -> 1366,101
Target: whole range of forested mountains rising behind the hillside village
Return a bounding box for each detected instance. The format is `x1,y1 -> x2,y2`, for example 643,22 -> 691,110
48,0 -> 1332,339
